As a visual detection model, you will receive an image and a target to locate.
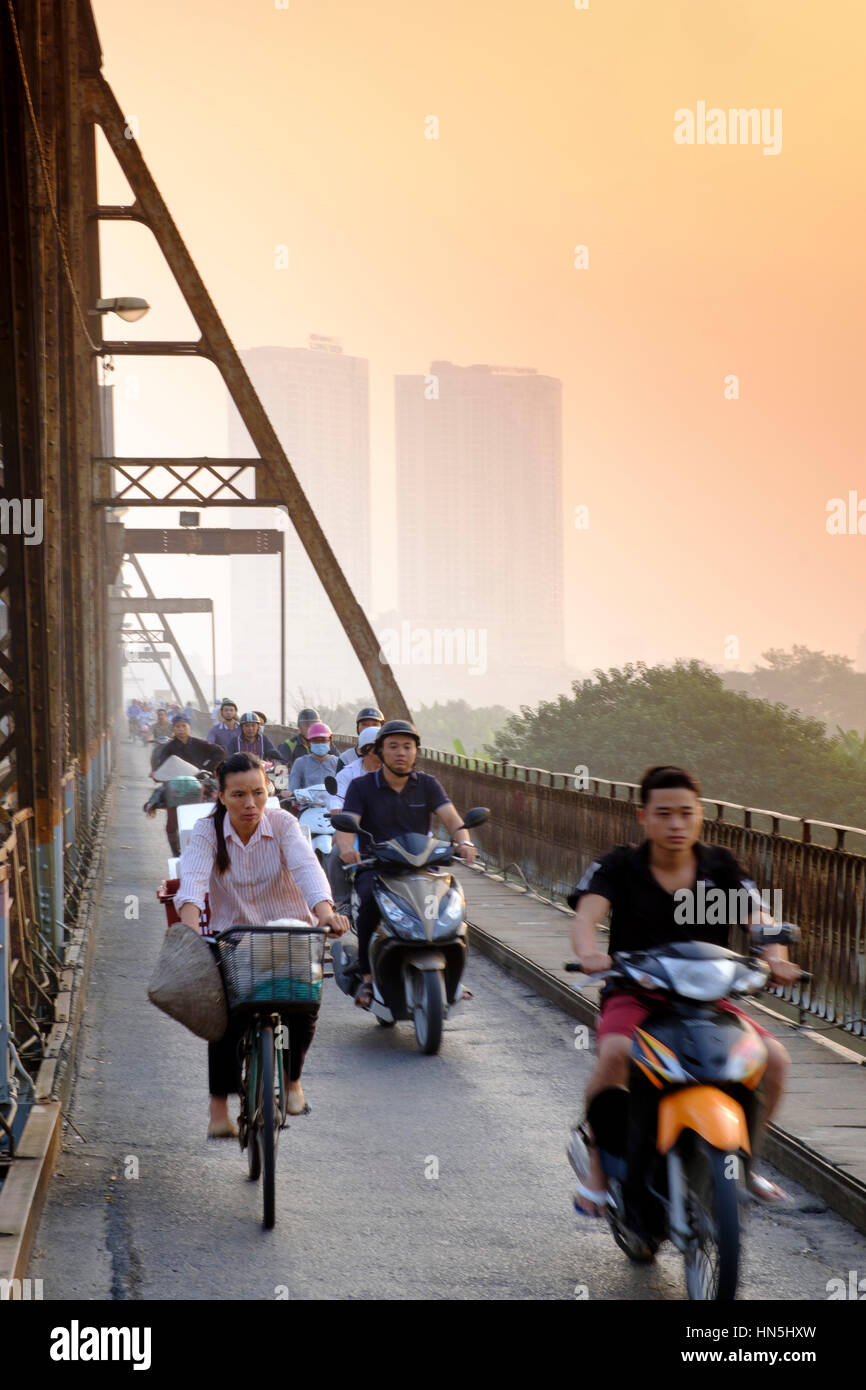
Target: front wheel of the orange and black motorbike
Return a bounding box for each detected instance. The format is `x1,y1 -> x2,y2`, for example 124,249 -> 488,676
680,1134 -> 740,1302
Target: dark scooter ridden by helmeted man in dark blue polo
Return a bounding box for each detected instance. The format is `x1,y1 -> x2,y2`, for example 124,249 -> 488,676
331,806 -> 489,1056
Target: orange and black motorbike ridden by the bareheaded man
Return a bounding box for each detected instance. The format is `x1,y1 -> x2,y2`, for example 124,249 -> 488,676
566,923 -> 799,1301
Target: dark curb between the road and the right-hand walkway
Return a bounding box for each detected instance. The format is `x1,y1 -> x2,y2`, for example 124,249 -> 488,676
467,922 -> 866,1234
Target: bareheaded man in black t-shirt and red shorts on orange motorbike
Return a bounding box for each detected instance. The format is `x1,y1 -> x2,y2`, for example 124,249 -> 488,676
569,766 -> 801,1216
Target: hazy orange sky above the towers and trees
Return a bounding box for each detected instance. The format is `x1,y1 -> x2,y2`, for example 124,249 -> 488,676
95,0 -> 866,683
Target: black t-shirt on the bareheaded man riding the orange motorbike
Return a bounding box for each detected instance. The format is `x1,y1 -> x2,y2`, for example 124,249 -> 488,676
569,840 -> 760,954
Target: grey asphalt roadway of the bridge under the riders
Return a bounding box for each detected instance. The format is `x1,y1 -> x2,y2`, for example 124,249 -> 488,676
29,756 -> 866,1300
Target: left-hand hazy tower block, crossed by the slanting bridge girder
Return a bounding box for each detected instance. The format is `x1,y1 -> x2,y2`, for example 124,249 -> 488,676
229,334 -> 370,706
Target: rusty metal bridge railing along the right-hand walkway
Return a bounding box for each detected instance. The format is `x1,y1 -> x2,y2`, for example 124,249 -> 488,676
418,748 -> 866,1037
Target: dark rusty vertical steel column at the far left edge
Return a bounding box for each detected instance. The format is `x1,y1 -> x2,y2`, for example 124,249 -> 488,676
0,0 -> 63,942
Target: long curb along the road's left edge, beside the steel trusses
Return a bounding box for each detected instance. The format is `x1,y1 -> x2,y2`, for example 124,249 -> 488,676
0,773 -> 114,1282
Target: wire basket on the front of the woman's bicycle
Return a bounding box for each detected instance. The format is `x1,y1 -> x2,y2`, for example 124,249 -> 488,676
215,919 -> 325,1013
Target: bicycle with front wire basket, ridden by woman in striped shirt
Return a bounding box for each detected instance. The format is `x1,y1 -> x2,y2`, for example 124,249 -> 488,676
214,919 -> 327,1230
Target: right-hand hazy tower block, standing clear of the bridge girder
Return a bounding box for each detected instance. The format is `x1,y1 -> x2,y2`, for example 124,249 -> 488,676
392,361 -> 567,706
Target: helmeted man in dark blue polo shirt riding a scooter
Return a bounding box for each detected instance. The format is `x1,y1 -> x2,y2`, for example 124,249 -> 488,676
336,719 -> 475,1009
